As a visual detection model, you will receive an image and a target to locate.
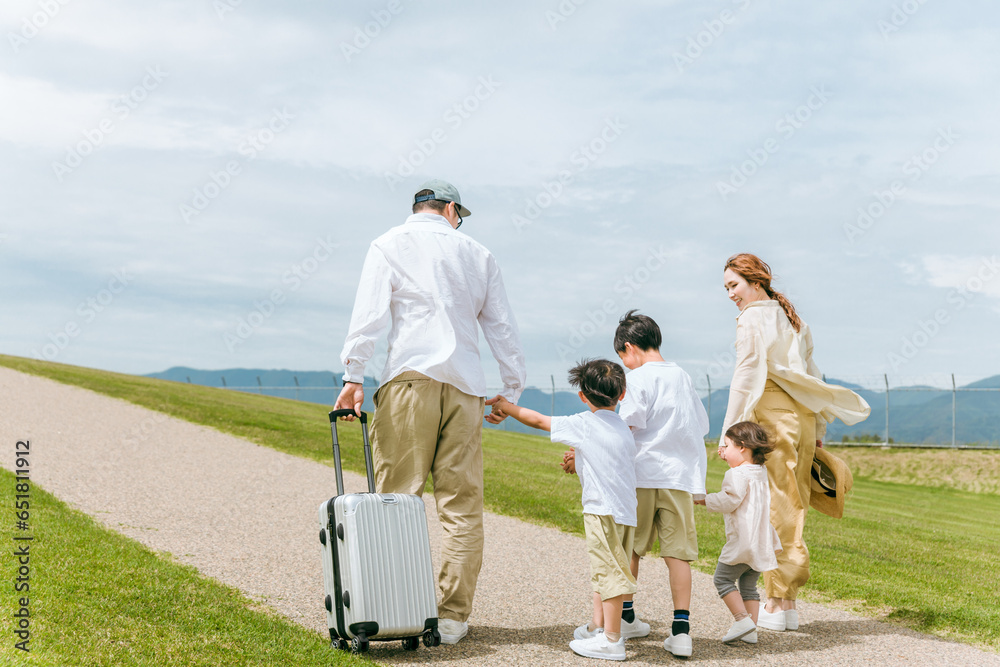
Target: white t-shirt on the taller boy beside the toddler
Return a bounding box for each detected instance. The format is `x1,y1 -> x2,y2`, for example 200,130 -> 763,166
619,361 -> 709,494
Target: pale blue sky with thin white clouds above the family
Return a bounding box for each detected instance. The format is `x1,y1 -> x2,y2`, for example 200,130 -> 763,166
0,0 -> 1000,394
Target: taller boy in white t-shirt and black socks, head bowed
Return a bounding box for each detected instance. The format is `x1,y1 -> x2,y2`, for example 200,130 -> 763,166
614,310 -> 709,657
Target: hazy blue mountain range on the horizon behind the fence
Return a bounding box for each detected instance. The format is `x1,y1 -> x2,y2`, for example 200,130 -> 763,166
148,367 -> 1000,444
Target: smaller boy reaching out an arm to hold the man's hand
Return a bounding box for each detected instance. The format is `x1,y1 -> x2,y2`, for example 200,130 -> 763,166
486,359 -> 635,660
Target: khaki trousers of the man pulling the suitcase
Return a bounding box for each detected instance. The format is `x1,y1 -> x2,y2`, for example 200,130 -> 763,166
372,371 -> 485,622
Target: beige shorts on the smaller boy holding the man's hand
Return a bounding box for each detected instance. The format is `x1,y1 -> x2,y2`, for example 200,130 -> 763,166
583,514 -> 636,600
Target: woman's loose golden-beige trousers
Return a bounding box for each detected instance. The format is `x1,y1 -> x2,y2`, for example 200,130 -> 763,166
754,380 -> 816,600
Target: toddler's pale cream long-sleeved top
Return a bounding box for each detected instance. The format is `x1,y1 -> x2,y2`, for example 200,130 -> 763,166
705,463 -> 781,572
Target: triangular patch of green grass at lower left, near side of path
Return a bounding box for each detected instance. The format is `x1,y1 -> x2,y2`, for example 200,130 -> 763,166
0,468 -> 374,667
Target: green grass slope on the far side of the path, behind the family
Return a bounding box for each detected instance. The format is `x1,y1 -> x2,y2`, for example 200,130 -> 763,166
0,356 -> 1000,650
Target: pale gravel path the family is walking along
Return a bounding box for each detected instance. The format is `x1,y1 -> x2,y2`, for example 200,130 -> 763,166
0,367 -> 1000,666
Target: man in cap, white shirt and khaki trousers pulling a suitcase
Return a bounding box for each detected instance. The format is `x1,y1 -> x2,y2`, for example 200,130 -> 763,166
335,180 -> 525,644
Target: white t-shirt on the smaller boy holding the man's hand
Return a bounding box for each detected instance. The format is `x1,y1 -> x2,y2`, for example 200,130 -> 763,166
552,410 -> 636,526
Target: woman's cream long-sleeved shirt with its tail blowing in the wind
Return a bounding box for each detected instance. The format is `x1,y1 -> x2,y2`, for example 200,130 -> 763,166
719,300 -> 871,443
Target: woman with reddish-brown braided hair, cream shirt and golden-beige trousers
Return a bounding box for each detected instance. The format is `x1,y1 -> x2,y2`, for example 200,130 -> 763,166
720,253 -> 871,631
